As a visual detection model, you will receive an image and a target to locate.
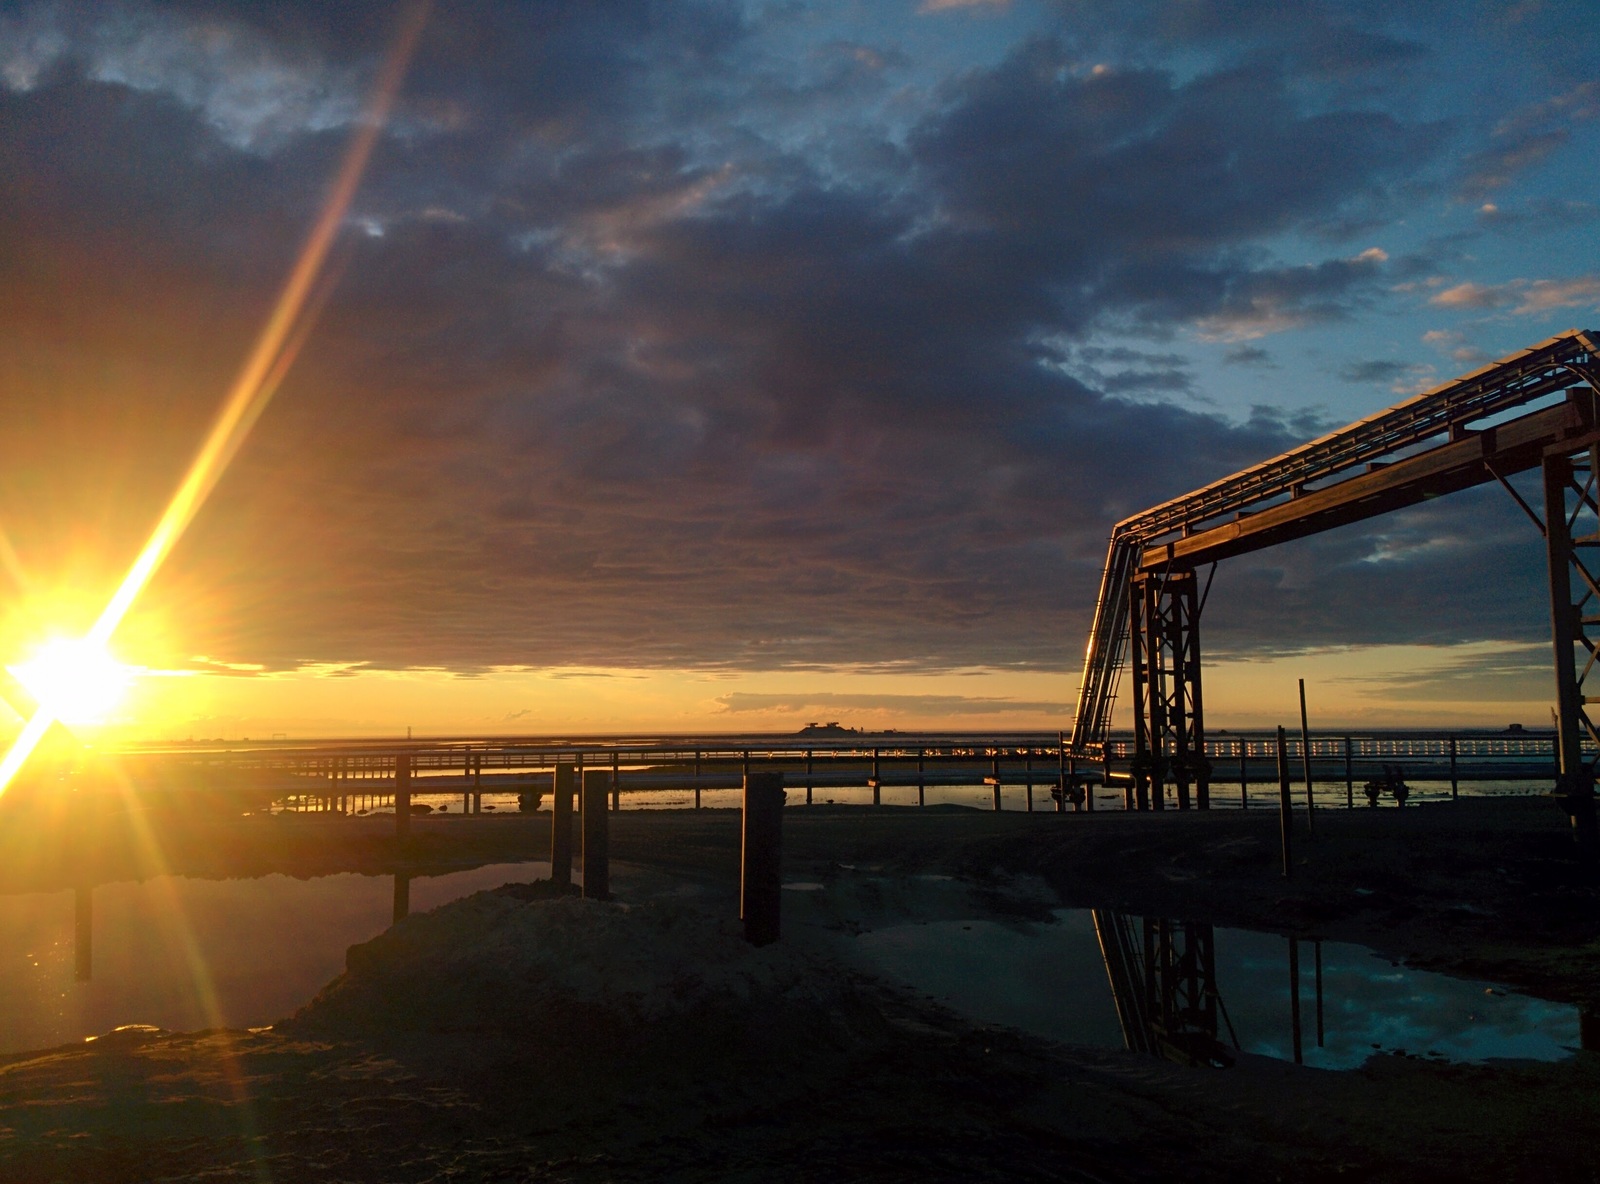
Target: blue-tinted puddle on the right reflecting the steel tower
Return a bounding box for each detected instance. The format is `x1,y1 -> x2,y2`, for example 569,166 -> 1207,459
853,909 -> 1579,1069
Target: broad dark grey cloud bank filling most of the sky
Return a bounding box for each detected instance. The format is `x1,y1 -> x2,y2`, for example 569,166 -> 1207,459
0,3 -> 1568,684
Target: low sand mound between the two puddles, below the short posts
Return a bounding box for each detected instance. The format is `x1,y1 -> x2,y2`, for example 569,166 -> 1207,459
290,891 -> 848,1032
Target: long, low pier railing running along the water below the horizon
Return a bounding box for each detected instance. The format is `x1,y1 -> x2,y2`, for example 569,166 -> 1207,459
50,731 -> 1574,813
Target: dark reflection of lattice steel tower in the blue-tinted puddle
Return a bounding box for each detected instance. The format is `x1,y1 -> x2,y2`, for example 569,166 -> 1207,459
1094,909 -> 1238,1069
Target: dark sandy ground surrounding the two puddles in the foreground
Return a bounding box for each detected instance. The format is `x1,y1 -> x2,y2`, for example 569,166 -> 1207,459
0,800 -> 1600,1181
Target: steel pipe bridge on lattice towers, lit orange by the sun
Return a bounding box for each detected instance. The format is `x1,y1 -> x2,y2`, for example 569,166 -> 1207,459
1072,330 -> 1600,850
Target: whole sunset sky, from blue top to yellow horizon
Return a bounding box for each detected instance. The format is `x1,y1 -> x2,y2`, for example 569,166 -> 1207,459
0,0 -> 1600,739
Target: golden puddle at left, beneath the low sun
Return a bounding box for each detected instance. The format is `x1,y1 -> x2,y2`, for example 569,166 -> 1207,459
0,862 -> 549,1053
